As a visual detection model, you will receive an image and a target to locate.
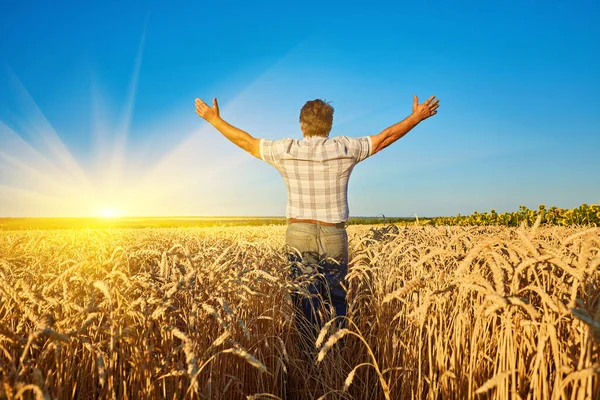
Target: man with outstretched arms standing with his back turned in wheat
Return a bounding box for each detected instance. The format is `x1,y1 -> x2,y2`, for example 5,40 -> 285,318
196,96 -> 439,336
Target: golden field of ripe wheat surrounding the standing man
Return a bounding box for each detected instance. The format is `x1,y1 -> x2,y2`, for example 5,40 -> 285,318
0,225 -> 600,400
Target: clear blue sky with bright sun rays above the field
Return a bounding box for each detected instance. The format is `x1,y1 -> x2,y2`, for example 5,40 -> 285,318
0,0 -> 600,216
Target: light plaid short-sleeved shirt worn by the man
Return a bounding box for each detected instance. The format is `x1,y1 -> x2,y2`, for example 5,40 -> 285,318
260,136 -> 372,223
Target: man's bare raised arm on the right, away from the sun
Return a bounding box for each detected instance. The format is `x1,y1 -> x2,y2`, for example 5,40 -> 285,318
371,95 -> 440,154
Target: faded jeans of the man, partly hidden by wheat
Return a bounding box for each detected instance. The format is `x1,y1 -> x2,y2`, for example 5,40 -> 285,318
285,223 -> 348,336
